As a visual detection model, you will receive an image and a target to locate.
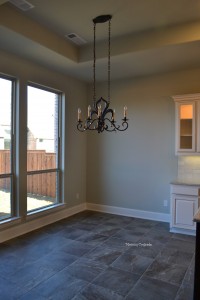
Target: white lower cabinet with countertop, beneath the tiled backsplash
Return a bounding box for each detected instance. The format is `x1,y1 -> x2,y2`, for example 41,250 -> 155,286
170,184 -> 199,233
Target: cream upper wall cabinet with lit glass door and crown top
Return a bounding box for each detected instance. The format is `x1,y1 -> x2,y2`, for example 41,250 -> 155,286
173,94 -> 200,155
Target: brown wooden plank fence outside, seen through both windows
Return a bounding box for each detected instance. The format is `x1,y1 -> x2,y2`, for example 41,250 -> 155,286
0,150 -> 56,198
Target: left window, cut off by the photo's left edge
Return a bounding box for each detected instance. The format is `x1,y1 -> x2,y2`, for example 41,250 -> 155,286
0,77 -> 14,221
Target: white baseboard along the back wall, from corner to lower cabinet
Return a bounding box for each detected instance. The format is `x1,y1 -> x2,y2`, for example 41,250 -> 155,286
86,203 -> 170,222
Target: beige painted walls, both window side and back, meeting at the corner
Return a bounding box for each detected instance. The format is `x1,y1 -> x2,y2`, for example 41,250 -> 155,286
0,44 -> 200,240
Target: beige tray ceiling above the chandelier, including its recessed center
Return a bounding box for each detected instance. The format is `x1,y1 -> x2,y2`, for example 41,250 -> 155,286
0,0 -> 200,82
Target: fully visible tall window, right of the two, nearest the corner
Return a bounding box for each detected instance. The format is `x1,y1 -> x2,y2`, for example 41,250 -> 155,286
27,85 -> 61,212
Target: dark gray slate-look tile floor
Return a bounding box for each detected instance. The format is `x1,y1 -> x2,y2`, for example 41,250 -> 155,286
0,211 -> 195,300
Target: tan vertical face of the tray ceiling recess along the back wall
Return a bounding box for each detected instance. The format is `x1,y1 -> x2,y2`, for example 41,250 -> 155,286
79,21 -> 200,62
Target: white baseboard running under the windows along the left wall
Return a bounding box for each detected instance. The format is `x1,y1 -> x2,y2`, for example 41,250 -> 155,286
0,203 -> 86,243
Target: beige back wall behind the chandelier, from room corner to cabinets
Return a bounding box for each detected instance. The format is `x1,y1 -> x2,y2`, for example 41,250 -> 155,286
87,70 -> 200,214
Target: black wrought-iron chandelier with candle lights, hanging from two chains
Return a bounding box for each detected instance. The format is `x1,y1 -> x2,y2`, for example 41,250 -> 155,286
77,15 -> 128,133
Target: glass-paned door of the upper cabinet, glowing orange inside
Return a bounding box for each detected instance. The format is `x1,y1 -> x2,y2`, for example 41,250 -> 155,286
178,102 -> 195,151
